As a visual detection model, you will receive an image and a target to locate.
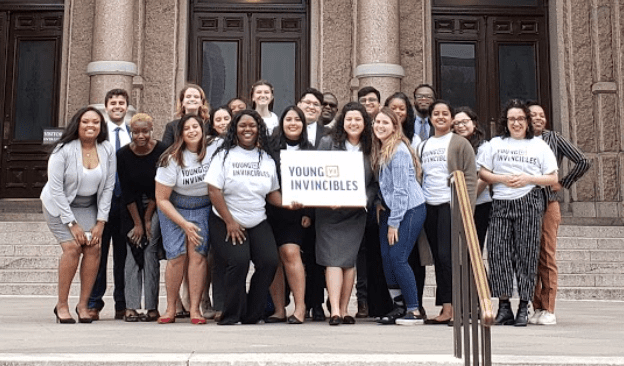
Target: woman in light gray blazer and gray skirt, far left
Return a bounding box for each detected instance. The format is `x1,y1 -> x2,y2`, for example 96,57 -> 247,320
41,107 -> 116,324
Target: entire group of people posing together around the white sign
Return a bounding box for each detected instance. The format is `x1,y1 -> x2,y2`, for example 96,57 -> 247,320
41,80 -> 589,326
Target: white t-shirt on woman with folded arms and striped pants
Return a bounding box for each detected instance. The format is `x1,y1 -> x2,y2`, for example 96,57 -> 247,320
477,137 -> 558,200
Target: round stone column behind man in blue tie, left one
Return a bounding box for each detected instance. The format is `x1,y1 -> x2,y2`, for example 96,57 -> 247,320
87,0 -> 137,105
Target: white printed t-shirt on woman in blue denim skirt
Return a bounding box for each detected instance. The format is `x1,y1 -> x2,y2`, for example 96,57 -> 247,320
155,139 -> 223,196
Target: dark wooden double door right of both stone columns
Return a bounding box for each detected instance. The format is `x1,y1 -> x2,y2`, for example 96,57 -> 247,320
432,0 -> 551,137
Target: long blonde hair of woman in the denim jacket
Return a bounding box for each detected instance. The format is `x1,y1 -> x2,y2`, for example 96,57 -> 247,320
371,107 -> 422,177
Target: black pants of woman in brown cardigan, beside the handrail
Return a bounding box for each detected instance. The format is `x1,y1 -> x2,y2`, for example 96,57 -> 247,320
425,203 -> 453,306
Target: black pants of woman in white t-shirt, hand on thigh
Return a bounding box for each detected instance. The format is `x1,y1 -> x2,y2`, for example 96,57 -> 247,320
209,213 -> 279,324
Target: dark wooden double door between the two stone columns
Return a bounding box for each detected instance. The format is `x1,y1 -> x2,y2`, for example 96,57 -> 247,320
189,0 -> 309,115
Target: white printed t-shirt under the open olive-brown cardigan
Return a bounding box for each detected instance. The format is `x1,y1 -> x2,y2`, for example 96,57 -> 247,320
419,132 -> 453,205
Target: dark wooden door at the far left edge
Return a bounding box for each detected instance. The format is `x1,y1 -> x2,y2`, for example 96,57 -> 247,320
0,11 -> 63,198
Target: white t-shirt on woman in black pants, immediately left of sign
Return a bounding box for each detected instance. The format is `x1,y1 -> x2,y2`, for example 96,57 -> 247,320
205,146 -> 279,228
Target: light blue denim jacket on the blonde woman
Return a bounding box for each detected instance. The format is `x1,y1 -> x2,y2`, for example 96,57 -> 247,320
379,143 -> 425,228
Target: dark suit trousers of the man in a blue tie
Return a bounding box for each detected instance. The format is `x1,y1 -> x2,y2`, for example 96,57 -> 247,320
85,195 -> 127,311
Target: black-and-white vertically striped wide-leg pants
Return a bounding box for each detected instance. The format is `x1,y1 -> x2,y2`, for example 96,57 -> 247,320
487,189 -> 544,301
